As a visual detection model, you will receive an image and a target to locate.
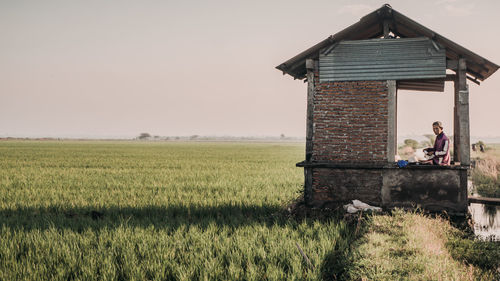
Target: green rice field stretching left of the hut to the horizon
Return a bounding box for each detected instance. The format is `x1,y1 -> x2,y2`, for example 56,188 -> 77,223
0,141 -> 353,280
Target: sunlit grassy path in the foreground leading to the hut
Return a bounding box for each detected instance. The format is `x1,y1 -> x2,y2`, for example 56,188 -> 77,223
349,210 -> 500,280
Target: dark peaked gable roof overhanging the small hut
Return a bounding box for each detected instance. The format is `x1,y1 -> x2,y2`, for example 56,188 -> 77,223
276,4 -> 499,81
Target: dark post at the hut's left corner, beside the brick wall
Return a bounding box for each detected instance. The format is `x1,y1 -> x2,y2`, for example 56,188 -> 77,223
304,59 -> 315,205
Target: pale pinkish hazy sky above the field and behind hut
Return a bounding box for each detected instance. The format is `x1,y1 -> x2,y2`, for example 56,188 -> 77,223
0,0 -> 500,138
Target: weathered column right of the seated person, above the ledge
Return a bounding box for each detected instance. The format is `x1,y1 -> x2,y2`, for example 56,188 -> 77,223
453,58 -> 470,166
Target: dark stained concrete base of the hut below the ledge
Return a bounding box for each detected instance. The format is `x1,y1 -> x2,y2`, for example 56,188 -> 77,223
298,163 -> 467,214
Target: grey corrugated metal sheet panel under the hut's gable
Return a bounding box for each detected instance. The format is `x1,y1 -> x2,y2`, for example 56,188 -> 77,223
319,37 -> 446,82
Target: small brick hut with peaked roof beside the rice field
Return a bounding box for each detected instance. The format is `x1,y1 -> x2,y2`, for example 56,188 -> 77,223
276,4 -> 499,213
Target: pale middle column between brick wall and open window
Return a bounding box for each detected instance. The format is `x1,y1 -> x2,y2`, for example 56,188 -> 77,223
387,80 -> 398,163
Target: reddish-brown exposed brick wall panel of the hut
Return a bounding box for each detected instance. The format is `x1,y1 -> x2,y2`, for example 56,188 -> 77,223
312,81 -> 389,163
